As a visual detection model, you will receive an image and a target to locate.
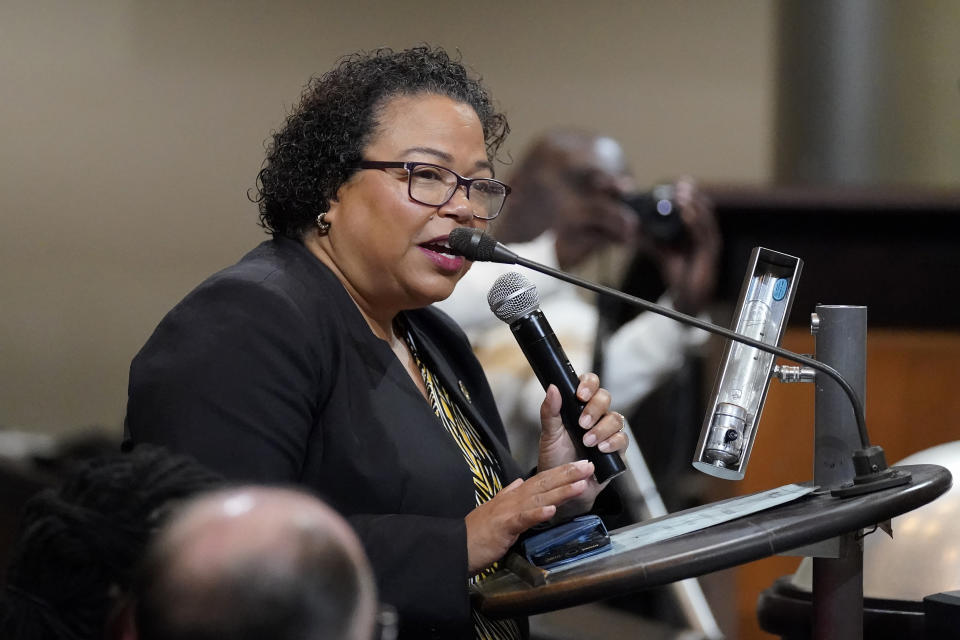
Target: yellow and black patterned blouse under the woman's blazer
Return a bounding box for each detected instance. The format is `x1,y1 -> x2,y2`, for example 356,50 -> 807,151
403,331 -> 520,640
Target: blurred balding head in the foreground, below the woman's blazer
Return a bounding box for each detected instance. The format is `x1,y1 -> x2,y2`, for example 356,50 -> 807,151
124,487 -> 377,640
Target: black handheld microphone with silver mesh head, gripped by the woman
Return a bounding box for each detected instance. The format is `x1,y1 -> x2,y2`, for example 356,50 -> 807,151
488,268 -> 626,482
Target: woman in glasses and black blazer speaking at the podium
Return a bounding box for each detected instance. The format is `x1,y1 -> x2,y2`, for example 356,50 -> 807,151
126,47 -> 627,638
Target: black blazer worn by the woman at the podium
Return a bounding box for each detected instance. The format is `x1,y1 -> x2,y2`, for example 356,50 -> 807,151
126,239 -> 520,638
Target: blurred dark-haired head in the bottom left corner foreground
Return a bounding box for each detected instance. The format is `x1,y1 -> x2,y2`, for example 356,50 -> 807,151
0,445 -> 221,640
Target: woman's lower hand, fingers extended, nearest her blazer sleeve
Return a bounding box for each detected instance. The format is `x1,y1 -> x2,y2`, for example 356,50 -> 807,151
465,460 -> 593,575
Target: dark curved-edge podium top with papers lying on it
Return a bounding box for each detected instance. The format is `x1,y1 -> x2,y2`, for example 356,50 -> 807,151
472,464 -> 951,617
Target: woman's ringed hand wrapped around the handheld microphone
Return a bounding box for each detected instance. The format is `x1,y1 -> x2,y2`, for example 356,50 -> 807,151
537,373 -> 629,516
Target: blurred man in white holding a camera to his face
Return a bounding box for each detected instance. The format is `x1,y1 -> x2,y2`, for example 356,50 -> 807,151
440,129 -> 721,466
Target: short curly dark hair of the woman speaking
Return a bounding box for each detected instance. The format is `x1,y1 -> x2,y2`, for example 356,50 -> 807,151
251,46 -> 510,239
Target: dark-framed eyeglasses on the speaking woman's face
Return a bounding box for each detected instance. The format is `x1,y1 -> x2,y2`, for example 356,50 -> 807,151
357,160 -> 510,220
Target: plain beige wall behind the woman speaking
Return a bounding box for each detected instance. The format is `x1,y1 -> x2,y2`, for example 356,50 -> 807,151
0,0 -> 773,432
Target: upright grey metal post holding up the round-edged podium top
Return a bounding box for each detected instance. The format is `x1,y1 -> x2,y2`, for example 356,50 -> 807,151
813,305 -> 867,640
